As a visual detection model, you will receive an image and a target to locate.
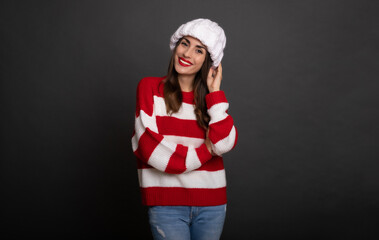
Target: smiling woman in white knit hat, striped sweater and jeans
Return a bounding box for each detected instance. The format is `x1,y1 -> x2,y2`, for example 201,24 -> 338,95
132,19 -> 237,240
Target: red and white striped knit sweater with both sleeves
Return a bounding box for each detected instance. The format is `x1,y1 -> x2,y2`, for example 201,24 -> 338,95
132,77 -> 237,206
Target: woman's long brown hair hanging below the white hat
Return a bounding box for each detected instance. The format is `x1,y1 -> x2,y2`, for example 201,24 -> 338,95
163,39 -> 212,129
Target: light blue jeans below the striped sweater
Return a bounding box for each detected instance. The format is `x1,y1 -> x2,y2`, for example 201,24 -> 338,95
148,204 -> 226,240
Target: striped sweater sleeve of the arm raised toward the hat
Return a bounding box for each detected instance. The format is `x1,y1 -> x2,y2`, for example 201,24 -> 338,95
205,91 -> 238,156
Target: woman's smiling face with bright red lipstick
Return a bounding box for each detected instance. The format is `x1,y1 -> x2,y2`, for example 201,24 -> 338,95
174,36 -> 207,77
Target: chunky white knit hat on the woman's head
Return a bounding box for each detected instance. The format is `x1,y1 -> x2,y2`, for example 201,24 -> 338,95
170,18 -> 226,67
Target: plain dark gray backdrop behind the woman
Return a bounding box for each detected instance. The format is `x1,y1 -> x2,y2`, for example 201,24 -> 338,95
0,0 -> 379,239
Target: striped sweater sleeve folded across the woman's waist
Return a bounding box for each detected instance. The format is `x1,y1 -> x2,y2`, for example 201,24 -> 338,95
132,79 -> 212,174
